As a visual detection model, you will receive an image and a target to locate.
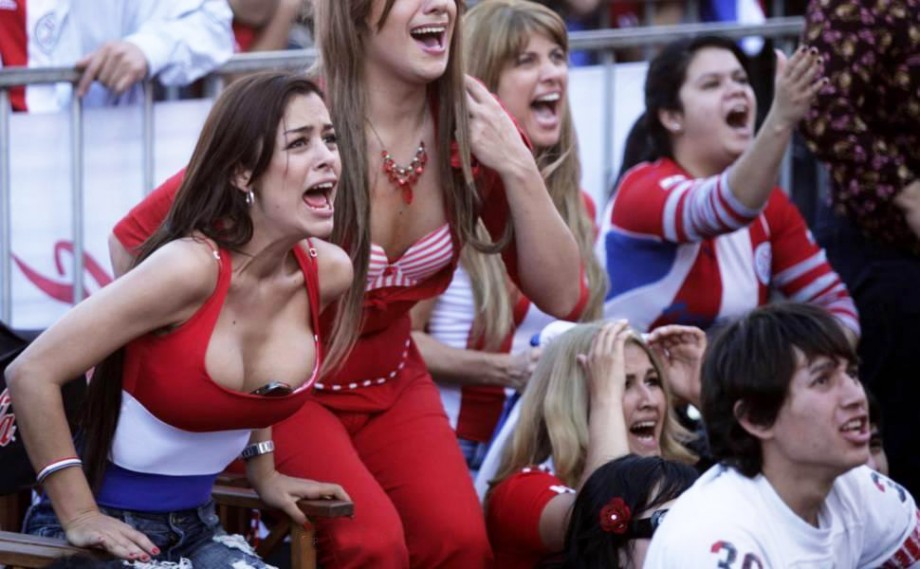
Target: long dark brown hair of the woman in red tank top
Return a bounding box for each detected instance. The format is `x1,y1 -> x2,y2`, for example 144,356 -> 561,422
81,72 -> 322,489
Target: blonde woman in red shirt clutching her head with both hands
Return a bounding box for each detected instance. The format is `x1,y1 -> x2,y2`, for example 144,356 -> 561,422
486,320 -> 706,569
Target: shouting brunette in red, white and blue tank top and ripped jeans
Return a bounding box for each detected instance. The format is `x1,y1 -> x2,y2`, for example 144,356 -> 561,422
7,72 -> 352,567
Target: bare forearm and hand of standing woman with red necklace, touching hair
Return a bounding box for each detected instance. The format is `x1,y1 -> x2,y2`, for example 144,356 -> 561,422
466,76 -> 585,318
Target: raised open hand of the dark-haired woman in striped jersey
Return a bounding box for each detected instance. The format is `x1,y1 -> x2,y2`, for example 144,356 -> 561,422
770,46 -> 828,128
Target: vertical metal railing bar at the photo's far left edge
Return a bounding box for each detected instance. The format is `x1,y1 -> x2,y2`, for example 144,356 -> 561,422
0,89 -> 13,328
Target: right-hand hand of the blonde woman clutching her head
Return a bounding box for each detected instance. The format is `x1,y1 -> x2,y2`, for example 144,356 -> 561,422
648,324 -> 706,408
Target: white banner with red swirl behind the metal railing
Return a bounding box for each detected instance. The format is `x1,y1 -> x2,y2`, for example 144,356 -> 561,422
10,63 -> 647,329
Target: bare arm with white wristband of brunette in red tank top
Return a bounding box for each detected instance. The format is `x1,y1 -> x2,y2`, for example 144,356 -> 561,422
6,241 -> 218,559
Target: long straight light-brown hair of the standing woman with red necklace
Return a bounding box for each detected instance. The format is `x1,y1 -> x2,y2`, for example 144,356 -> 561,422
313,0 -> 511,369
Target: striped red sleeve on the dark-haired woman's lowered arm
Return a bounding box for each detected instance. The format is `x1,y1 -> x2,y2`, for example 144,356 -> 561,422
765,190 -> 860,336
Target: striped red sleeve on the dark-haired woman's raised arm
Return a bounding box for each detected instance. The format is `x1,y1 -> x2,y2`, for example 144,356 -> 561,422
611,160 -> 762,243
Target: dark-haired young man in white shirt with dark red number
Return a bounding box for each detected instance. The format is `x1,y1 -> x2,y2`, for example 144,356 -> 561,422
645,303 -> 920,569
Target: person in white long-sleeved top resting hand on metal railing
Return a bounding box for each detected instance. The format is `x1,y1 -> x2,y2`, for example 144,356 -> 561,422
0,0 -> 233,113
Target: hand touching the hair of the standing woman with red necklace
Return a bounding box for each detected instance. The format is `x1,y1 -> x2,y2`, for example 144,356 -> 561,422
464,75 -> 536,175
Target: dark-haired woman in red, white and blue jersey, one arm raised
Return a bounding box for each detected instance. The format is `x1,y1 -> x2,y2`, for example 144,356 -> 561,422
599,36 -> 860,341
